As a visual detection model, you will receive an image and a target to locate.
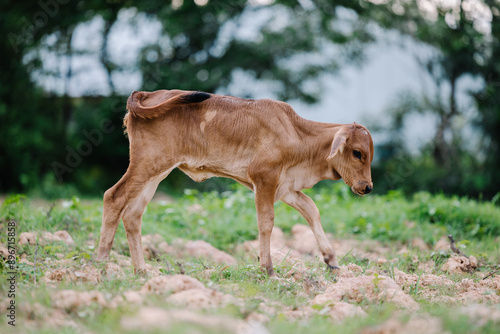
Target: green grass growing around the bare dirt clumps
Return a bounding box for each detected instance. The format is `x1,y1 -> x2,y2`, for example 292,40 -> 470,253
0,183 -> 500,334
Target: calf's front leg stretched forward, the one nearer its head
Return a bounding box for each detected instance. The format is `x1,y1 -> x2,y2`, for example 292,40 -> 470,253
281,191 -> 339,270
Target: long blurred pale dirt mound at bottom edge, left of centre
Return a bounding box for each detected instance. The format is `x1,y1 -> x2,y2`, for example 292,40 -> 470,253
120,307 -> 246,333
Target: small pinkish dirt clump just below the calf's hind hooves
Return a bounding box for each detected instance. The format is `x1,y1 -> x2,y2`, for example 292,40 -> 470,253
141,275 -> 205,295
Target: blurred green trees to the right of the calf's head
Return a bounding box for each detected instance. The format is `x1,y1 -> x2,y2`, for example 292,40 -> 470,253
362,0 -> 500,197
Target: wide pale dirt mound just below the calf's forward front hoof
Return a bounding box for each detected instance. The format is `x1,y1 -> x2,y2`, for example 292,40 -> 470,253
311,272 -> 419,311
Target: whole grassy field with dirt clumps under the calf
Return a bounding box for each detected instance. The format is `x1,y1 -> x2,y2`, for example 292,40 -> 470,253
0,183 -> 500,334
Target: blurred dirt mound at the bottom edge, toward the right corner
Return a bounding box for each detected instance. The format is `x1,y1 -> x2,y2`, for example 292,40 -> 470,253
361,314 -> 449,334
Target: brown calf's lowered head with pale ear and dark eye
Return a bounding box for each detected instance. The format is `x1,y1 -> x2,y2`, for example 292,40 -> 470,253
326,123 -> 373,196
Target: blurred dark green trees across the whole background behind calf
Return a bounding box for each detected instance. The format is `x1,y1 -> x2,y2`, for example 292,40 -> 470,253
0,0 -> 500,197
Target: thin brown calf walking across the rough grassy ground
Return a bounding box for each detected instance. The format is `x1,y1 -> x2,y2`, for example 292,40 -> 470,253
97,90 -> 373,275
